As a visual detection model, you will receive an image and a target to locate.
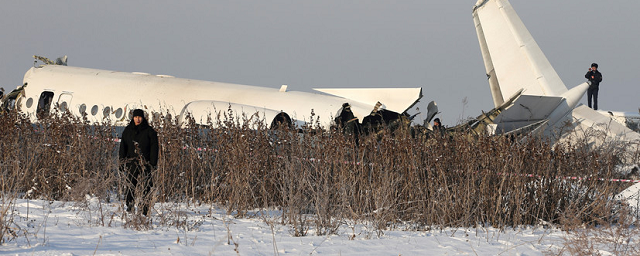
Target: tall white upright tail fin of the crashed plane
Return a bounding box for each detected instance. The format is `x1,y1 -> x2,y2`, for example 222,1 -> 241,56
473,0 -> 567,107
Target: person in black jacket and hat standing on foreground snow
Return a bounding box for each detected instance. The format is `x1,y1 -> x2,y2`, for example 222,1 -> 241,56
119,109 -> 159,215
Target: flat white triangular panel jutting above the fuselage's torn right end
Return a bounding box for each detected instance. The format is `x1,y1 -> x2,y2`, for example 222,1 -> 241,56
314,88 -> 422,113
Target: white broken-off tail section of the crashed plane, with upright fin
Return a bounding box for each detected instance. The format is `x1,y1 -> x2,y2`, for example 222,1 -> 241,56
473,0 -> 640,150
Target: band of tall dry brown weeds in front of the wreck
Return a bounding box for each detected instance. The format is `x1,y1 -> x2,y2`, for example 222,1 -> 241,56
0,106 -> 628,244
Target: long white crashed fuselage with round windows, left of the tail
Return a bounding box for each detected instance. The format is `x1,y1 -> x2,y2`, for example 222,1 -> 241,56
16,65 -> 422,127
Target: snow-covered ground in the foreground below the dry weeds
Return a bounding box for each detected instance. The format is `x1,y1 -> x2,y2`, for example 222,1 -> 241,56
0,197 -> 632,256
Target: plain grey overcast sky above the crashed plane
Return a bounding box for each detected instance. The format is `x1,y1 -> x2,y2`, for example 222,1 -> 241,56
0,0 -> 640,126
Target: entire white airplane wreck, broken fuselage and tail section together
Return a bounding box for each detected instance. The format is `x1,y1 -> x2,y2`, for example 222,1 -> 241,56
3,0 -> 640,152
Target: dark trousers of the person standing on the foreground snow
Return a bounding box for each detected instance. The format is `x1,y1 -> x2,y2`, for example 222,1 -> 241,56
125,163 -> 153,215
